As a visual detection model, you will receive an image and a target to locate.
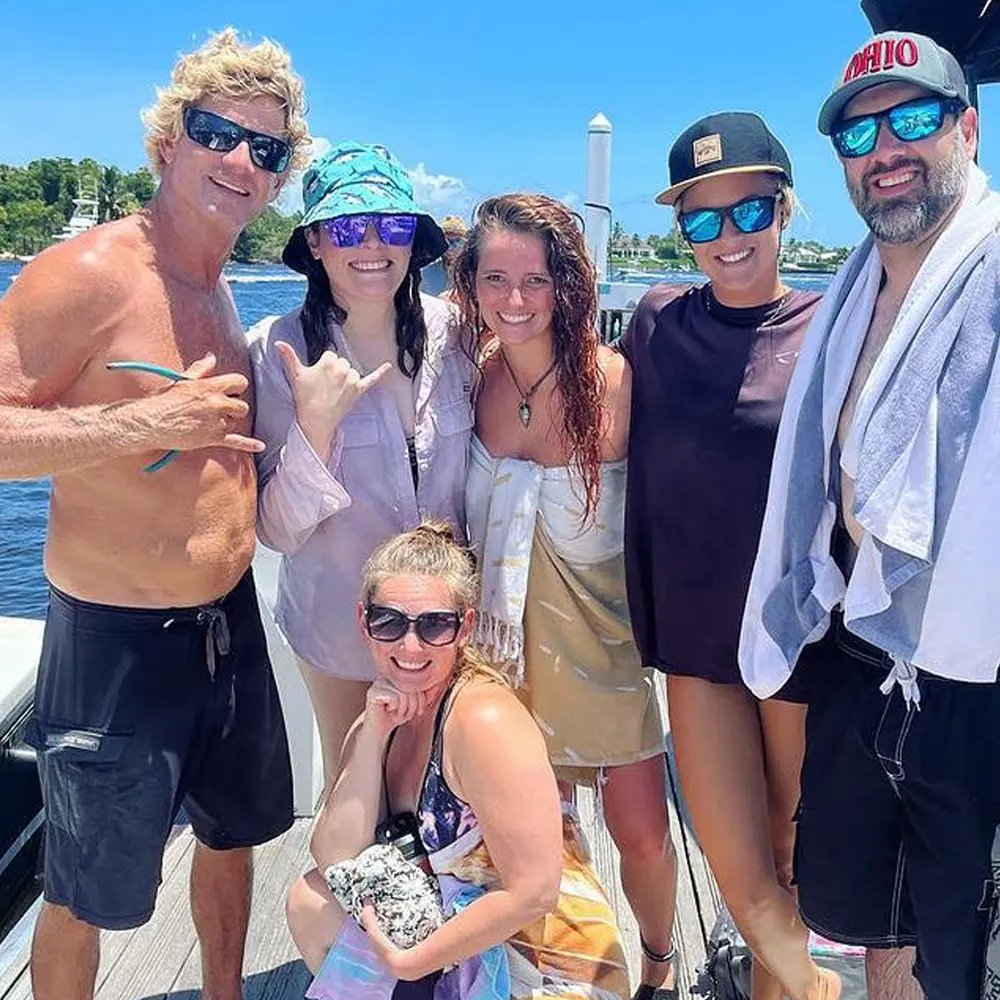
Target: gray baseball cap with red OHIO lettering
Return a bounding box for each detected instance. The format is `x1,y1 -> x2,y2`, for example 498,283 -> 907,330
819,31 -> 969,135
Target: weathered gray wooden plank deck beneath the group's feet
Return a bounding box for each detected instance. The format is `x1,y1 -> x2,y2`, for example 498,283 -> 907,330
0,680 -> 719,1000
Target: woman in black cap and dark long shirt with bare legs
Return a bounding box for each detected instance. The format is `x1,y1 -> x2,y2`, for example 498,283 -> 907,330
621,112 -> 840,1000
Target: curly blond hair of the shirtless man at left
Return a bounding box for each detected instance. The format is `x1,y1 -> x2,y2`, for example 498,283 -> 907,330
142,28 -> 310,176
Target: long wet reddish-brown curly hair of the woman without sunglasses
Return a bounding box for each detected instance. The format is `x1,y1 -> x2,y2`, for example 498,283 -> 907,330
452,194 -> 606,521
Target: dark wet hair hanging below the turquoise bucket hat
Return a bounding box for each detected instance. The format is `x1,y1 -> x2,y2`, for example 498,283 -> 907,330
300,234 -> 427,379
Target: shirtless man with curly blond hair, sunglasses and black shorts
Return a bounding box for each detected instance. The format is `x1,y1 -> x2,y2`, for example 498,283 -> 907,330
0,29 -> 308,1000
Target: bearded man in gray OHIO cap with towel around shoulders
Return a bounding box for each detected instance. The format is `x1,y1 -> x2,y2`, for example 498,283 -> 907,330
740,32 -> 1000,1000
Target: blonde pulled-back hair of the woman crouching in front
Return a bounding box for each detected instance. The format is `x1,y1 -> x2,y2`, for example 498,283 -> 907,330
361,520 -> 507,684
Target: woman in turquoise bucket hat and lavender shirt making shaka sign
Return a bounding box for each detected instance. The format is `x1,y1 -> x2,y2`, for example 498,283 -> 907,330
251,142 -> 474,784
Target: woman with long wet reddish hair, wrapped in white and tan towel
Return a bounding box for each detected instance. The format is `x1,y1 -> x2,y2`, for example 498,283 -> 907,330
454,194 -> 676,1000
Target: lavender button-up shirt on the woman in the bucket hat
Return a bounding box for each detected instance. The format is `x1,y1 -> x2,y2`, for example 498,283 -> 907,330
249,296 -> 474,680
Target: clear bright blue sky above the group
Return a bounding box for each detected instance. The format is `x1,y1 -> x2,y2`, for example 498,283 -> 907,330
0,0 -> 1000,243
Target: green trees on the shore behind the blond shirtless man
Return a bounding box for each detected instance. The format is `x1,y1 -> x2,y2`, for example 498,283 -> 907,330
0,157 -> 301,262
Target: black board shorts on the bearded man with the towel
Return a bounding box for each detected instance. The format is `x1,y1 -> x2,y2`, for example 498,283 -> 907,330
794,613 -> 1000,1000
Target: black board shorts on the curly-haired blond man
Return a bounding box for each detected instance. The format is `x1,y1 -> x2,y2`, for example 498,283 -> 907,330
26,570 -> 292,929
